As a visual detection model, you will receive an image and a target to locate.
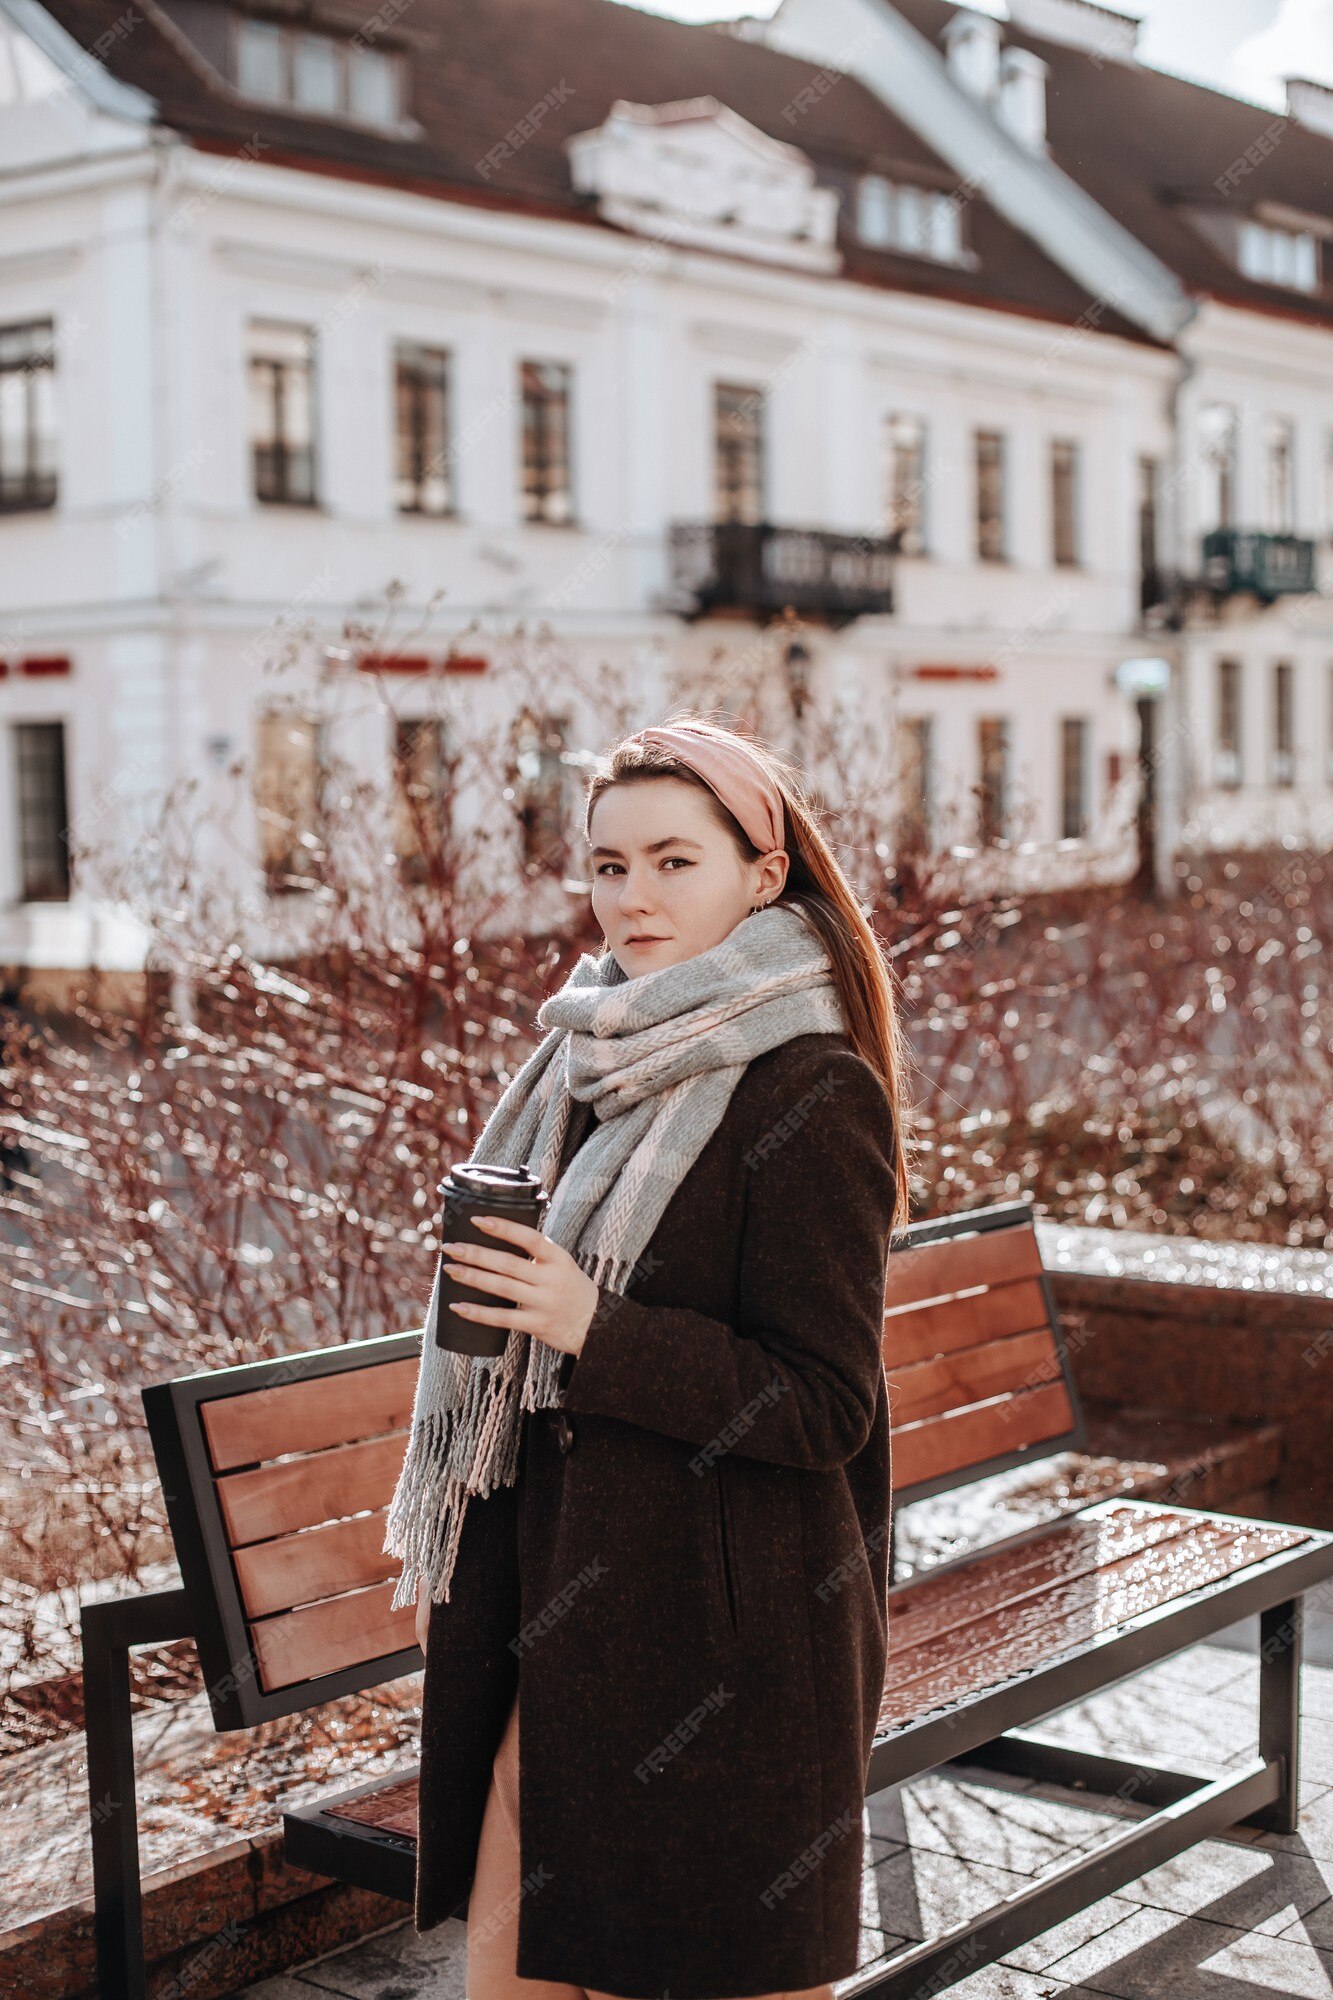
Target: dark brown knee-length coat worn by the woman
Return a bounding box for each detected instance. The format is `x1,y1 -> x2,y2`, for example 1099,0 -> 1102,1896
416,1034 -> 895,2000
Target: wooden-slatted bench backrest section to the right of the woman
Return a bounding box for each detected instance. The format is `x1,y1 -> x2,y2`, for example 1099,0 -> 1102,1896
885,1202 -> 1083,1500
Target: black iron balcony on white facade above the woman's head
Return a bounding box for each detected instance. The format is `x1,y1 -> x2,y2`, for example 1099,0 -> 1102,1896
671,520 -> 897,626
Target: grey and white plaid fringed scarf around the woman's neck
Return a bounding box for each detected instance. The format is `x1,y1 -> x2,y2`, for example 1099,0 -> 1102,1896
384,898 -> 845,1610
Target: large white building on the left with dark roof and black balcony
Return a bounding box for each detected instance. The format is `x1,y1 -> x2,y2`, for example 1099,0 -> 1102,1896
0,0 -> 1333,966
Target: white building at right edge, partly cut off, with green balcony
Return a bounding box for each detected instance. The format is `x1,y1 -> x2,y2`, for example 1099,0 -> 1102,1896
769,0 -> 1333,846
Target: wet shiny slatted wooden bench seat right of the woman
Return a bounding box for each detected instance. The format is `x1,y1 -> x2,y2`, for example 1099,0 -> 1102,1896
881,1520 -> 1309,1728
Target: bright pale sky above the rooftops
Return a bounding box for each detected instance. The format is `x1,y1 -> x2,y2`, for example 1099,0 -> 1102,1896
634,0 -> 1333,104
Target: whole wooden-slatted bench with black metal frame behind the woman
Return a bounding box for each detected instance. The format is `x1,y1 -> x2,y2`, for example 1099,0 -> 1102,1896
82,1202 -> 1333,2000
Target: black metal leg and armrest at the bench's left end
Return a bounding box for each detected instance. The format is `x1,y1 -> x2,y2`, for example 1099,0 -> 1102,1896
80,1590 -> 194,2000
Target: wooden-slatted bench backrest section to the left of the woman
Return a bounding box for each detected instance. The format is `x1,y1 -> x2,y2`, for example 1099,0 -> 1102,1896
142,1332 -> 422,1730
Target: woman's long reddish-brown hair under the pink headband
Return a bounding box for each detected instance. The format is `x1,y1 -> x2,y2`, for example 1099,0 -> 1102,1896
582,712 -> 913,1236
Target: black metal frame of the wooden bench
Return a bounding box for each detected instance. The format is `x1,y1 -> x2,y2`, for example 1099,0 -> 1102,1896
82,1202 -> 1333,2000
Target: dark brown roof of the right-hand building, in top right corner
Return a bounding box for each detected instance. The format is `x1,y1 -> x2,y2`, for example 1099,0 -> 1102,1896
893,0 -> 1333,324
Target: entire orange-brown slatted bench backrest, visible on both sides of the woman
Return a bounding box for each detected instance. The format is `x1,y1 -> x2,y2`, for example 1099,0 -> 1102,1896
142,1202 -> 1083,1728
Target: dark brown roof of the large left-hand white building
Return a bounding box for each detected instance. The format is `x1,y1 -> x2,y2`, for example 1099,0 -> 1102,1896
42,0 -> 1145,340
